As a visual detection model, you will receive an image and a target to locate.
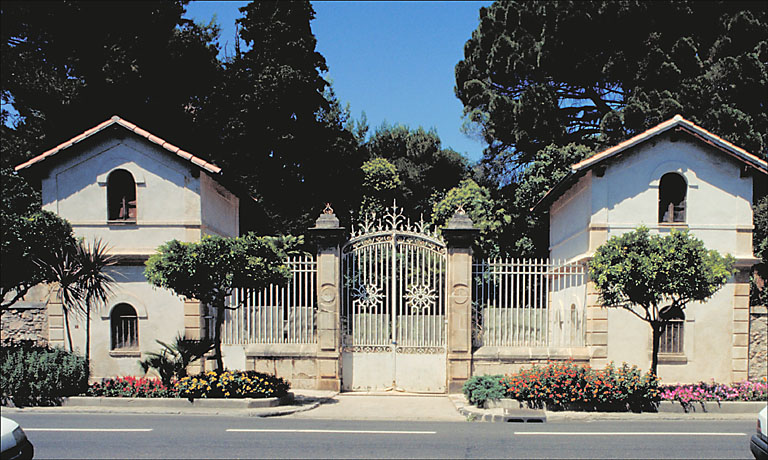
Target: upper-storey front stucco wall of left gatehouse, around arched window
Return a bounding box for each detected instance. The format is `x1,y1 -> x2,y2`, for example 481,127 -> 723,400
42,136 -> 204,254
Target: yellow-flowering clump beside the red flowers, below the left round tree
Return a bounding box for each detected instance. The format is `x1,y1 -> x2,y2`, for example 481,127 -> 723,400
176,371 -> 290,399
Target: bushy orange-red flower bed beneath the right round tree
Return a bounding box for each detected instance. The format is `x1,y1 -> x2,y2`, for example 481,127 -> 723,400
501,361 -> 659,411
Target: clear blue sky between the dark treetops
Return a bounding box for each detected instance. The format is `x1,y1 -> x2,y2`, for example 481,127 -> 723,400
187,1 -> 491,164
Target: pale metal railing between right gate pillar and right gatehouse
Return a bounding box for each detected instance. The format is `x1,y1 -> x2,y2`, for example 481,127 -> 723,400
472,259 -> 586,347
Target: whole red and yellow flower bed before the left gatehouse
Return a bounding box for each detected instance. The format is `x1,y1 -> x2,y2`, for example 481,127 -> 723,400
85,371 -> 290,399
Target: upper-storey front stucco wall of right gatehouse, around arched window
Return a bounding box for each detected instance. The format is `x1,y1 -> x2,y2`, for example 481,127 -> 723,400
590,136 -> 752,257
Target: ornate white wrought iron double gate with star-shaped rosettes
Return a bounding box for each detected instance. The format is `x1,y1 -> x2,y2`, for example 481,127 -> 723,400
341,205 -> 446,393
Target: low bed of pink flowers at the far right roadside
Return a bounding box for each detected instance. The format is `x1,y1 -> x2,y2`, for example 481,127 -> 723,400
661,378 -> 768,411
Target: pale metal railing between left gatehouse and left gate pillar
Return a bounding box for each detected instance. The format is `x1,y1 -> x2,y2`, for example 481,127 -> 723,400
223,256 -> 317,345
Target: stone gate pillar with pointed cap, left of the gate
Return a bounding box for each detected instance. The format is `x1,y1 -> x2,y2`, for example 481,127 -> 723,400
309,204 -> 344,391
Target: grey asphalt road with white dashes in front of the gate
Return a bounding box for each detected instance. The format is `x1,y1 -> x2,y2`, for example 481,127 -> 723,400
9,413 -> 755,459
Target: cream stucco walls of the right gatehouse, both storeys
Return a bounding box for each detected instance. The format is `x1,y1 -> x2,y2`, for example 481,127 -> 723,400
550,133 -> 752,382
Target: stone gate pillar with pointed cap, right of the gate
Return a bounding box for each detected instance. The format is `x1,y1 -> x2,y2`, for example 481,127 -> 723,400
443,208 -> 479,393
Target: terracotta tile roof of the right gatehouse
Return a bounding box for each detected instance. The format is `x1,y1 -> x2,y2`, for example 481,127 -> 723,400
531,115 -> 768,211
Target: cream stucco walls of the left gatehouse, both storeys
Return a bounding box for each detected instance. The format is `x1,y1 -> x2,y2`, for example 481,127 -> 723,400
28,128 -> 234,378
